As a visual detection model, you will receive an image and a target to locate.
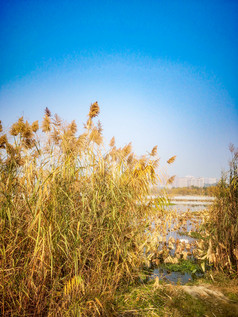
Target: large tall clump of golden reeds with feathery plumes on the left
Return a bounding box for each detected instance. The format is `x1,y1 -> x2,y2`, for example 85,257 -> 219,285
0,103 -> 166,316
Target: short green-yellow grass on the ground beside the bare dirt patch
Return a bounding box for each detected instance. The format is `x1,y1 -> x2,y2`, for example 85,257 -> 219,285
115,273 -> 238,317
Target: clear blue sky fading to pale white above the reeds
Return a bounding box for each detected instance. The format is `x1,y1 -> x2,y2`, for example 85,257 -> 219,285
0,0 -> 238,177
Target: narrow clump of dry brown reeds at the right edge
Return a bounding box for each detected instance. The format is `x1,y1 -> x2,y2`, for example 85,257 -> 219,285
205,145 -> 238,275
